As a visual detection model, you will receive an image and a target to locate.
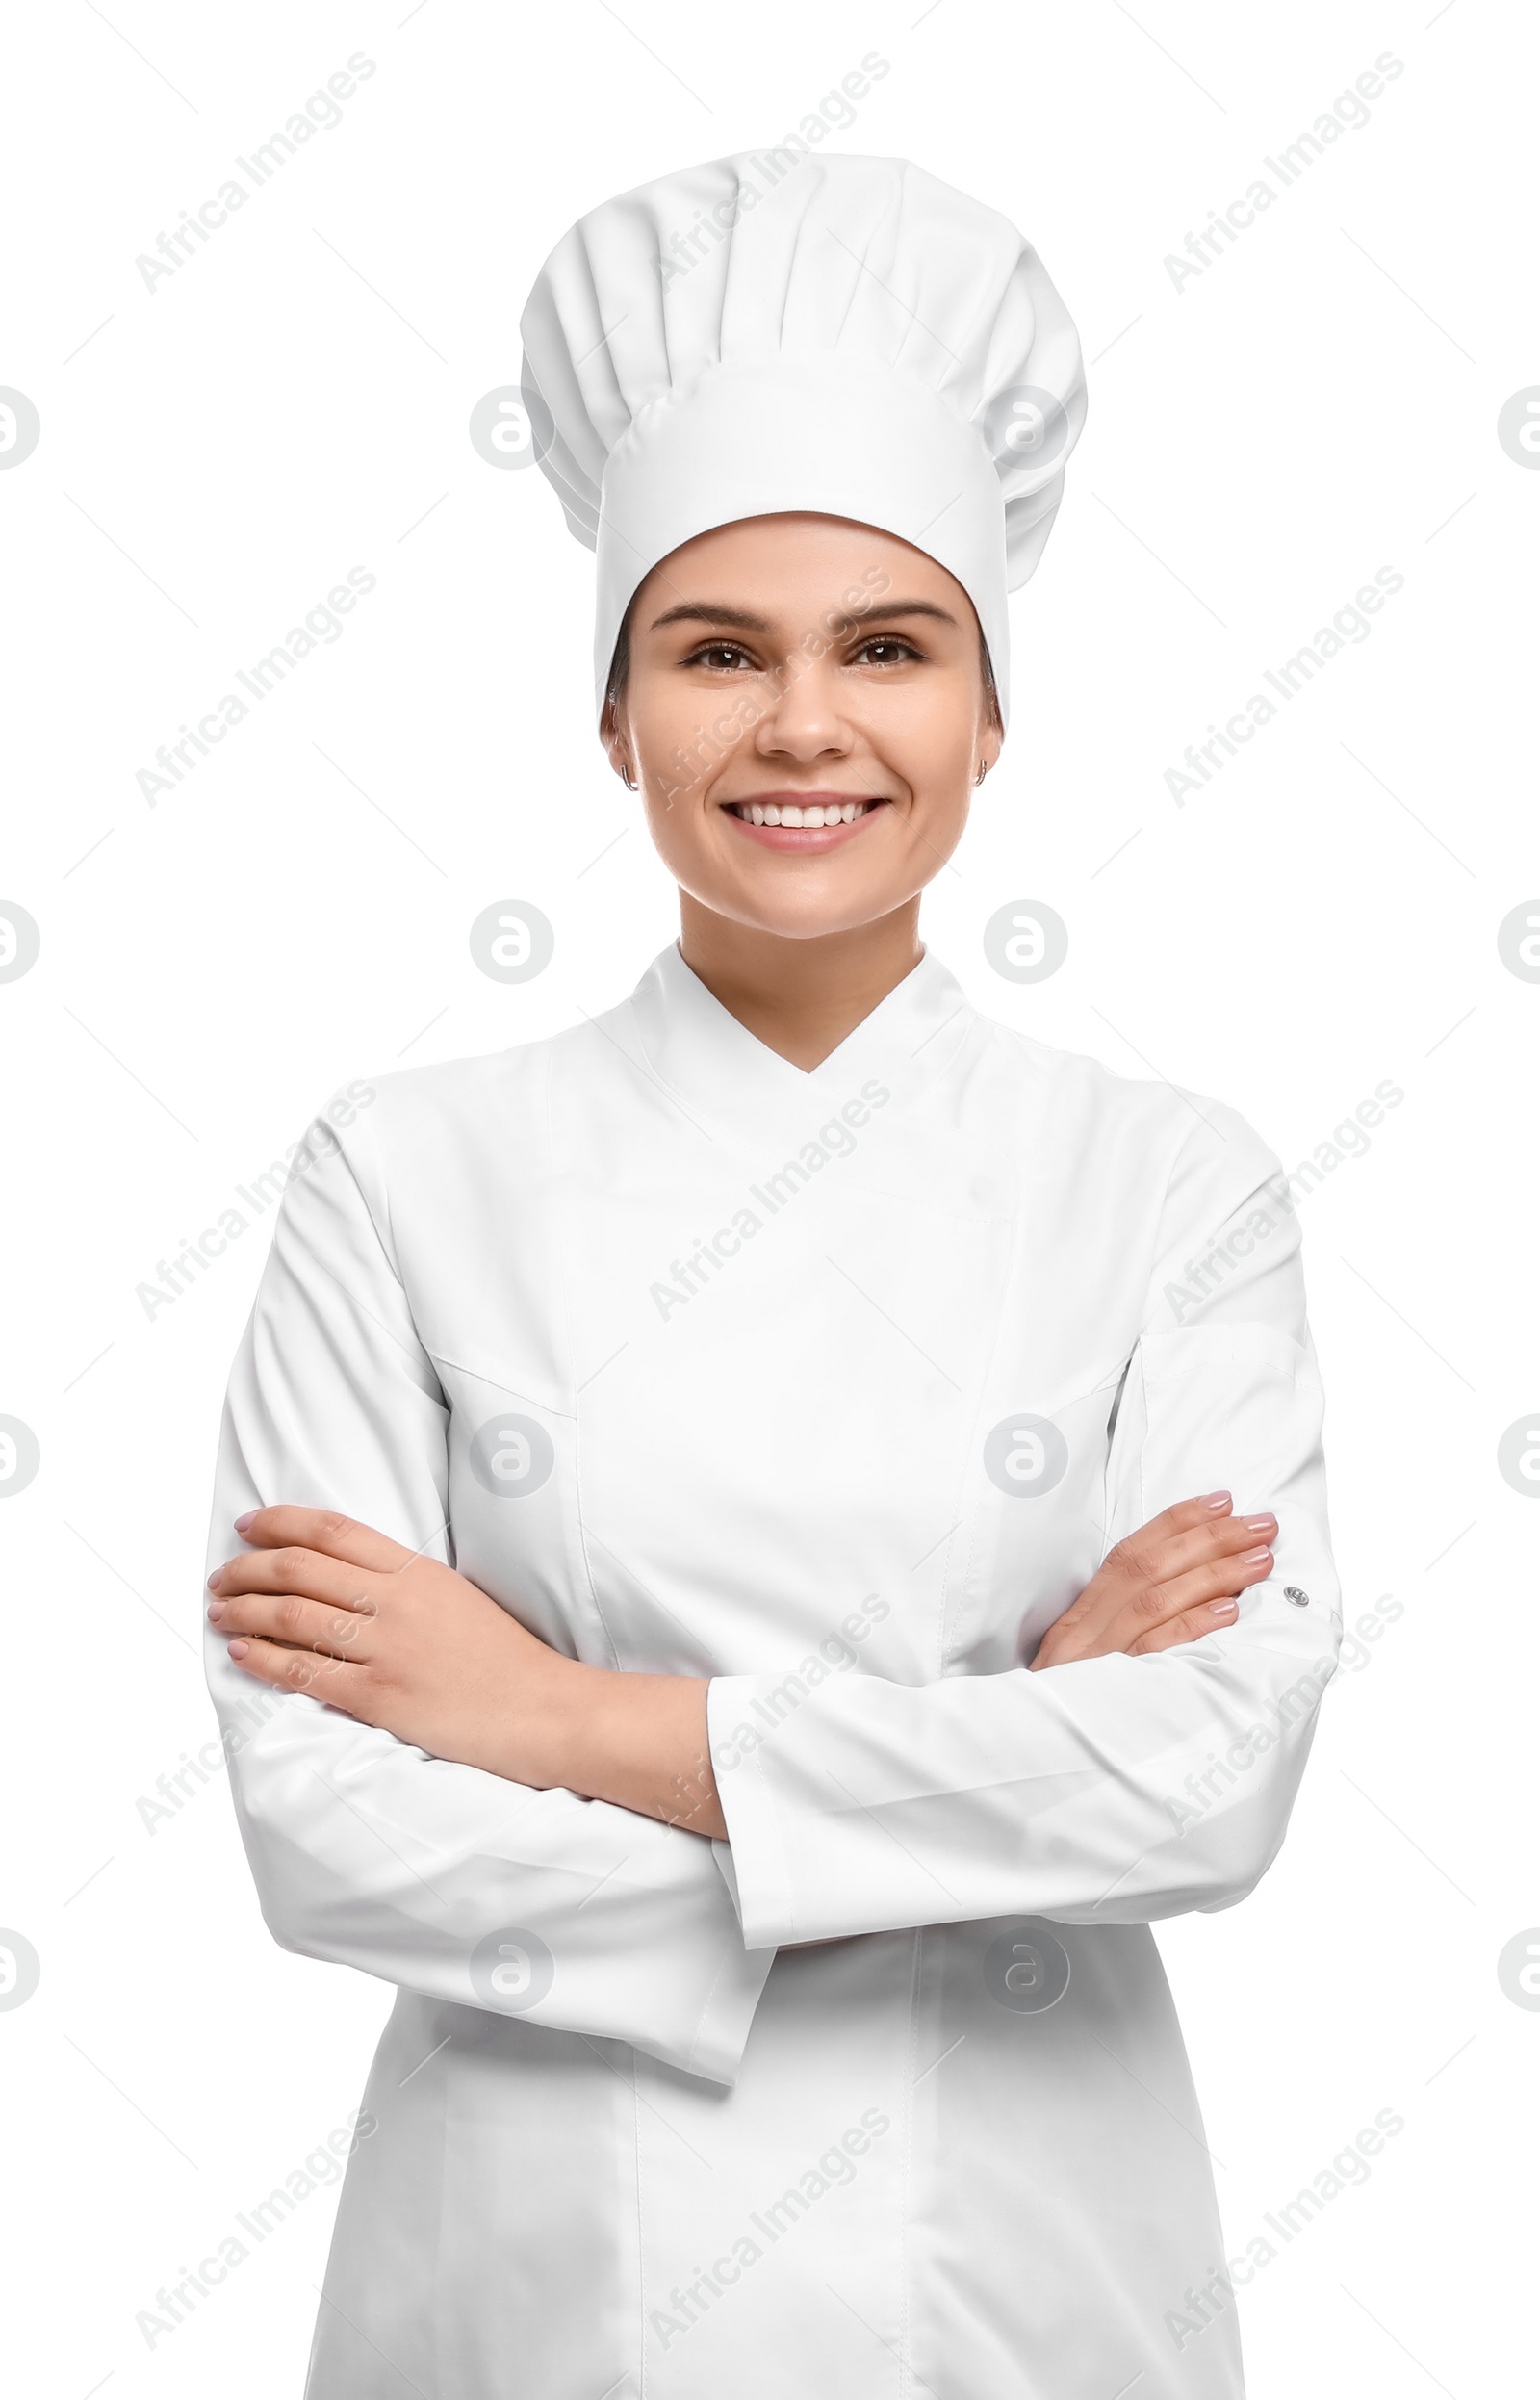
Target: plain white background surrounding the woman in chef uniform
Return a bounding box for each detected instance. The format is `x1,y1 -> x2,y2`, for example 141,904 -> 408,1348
0,0 -> 1540,2400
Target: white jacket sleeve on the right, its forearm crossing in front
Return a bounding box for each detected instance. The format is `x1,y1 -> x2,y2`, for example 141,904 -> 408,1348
710,1104 -> 1341,1944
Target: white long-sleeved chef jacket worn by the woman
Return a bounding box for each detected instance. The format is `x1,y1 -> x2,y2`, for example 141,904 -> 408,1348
206,948 -> 1339,2400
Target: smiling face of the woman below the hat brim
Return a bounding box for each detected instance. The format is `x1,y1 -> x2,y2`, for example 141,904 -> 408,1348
607,514 -> 1000,939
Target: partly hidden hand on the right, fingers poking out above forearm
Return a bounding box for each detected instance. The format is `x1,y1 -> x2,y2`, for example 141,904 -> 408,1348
1032,1493 -> 1278,1670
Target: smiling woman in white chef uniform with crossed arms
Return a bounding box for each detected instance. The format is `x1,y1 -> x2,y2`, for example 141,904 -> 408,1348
209,159 -> 1339,2400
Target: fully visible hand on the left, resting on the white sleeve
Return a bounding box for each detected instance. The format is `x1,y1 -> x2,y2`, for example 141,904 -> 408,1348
209,1508 -> 580,1783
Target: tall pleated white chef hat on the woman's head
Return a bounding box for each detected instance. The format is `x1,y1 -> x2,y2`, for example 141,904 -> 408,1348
521,149 -> 1087,712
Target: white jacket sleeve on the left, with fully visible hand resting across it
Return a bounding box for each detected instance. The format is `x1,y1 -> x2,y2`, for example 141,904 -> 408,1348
206,1094 -> 770,2083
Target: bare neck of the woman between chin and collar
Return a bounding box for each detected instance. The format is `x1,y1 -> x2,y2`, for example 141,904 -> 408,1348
679,892 -> 924,1072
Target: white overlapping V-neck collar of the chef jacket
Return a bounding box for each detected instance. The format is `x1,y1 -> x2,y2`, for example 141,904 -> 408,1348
630,943 -> 976,1140
